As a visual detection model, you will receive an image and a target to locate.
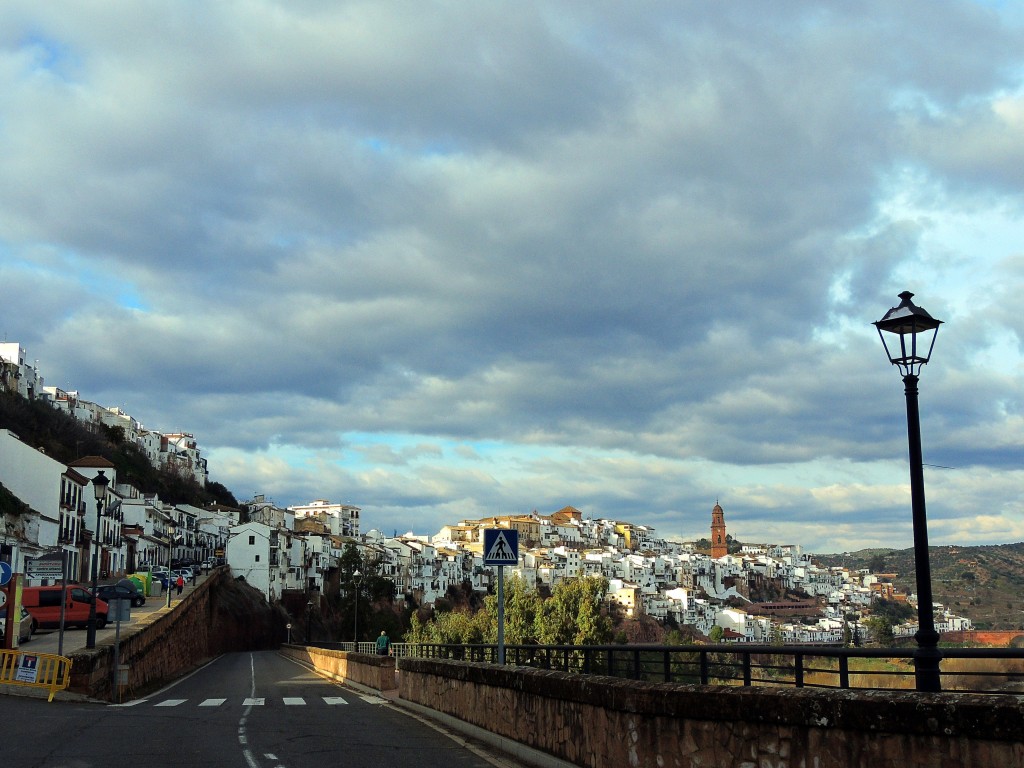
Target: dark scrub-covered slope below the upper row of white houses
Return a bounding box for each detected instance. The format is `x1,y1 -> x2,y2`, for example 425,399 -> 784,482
0,392 -> 239,507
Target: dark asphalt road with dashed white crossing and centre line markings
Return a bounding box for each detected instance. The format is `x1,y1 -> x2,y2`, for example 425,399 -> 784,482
0,651 -> 518,768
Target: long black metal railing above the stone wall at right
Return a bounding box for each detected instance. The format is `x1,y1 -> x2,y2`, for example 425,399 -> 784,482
403,643 -> 1024,693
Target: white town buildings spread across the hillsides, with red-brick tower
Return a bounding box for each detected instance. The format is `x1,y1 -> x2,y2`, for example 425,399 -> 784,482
0,342 -> 973,644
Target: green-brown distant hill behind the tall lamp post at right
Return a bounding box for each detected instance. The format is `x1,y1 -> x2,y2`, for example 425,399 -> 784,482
815,542 -> 1024,630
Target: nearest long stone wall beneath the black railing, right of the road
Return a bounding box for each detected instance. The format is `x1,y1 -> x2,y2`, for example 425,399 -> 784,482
398,658 -> 1024,768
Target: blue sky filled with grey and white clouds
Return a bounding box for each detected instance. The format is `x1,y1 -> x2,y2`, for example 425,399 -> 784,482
0,0 -> 1024,552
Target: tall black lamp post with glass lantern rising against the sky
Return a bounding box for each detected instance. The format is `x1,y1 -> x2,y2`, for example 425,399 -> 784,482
874,291 -> 942,691
